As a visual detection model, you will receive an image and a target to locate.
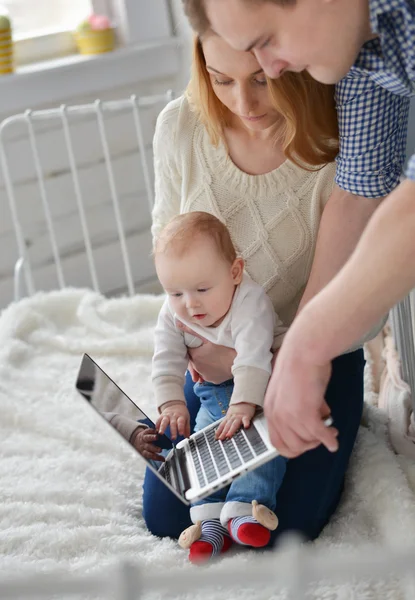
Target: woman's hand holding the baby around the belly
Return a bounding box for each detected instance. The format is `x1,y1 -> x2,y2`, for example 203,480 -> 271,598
177,321 -> 236,384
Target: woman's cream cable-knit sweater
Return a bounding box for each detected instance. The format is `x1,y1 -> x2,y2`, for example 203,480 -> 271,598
152,97 -> 379,345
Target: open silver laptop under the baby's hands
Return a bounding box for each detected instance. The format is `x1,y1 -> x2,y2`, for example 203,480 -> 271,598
76,354 -> 278,505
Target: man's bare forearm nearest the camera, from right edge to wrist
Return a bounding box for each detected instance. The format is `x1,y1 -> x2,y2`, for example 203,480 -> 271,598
296,179 -> 415,364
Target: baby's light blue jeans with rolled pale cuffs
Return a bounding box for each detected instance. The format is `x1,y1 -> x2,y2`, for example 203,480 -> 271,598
190,379 -> 287,526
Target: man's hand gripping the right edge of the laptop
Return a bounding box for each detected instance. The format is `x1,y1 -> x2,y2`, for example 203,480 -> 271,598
264,326 -> 338,458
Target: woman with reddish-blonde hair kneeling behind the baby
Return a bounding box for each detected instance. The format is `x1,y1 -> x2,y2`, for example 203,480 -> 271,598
143,33 -> 364,541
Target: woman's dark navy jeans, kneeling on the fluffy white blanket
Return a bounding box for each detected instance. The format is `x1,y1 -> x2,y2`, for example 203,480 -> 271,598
143,350 -> 365,544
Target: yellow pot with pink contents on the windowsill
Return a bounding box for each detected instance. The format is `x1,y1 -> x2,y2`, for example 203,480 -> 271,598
74,15 -> 115,54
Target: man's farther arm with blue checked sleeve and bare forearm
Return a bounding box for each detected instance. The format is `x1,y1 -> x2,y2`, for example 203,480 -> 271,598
299,73 -> 409,311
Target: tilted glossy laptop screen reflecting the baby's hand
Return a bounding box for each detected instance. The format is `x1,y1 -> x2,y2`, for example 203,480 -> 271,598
76,354 -> 188,504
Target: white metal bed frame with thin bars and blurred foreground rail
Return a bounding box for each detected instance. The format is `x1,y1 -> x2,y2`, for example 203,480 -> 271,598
0,91 -> 415,600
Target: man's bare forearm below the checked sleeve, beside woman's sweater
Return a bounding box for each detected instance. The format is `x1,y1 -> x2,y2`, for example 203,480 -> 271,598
298,186 -> 382,312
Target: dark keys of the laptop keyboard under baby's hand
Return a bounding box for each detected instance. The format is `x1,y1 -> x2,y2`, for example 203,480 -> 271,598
189,425 -> 267,486
